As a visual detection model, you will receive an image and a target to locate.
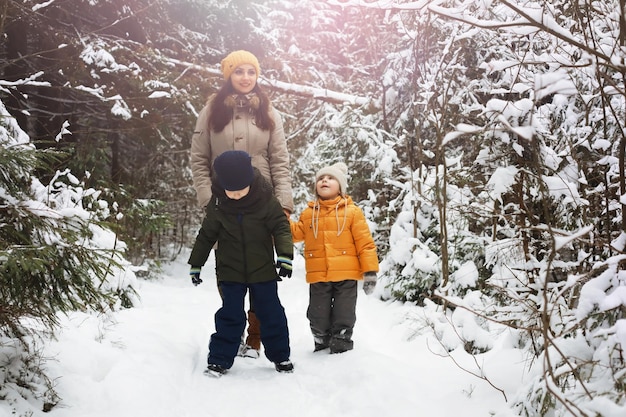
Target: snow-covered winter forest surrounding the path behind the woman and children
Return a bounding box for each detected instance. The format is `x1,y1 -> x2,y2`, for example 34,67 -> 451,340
0,0 -> 626,417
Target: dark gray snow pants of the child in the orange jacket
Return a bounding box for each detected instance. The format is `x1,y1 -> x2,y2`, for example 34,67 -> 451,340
307,280 -> 357,353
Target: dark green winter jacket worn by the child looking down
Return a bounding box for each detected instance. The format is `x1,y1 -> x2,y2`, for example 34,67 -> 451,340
188,168 -> 293,283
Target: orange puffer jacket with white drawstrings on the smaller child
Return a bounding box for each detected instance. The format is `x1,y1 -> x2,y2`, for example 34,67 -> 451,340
291,196 -> 378,284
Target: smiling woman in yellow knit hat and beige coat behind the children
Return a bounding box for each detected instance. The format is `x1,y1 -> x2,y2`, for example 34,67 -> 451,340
191,50 -> 293,357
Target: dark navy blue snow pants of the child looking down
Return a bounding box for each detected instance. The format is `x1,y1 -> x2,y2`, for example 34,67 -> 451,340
208,281 -> 291,369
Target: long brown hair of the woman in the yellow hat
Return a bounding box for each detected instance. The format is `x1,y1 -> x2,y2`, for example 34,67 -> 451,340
209,80 -> 276,132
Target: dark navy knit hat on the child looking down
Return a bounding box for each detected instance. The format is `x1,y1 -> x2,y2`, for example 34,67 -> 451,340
213,151 -> 254,191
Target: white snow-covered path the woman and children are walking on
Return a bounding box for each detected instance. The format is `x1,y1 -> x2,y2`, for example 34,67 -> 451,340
42,257 -> 506,417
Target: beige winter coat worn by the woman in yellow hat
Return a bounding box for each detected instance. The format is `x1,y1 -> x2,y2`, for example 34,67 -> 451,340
191,96 -> 293,212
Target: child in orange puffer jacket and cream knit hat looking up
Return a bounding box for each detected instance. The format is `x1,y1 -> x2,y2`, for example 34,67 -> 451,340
291,162 -> 378,353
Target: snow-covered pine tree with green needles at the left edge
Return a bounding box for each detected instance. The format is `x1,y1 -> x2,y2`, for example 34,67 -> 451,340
0,98 -> 135,410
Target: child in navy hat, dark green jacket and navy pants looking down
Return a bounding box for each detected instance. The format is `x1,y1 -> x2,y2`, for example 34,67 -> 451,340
188,151 -> 293,376
